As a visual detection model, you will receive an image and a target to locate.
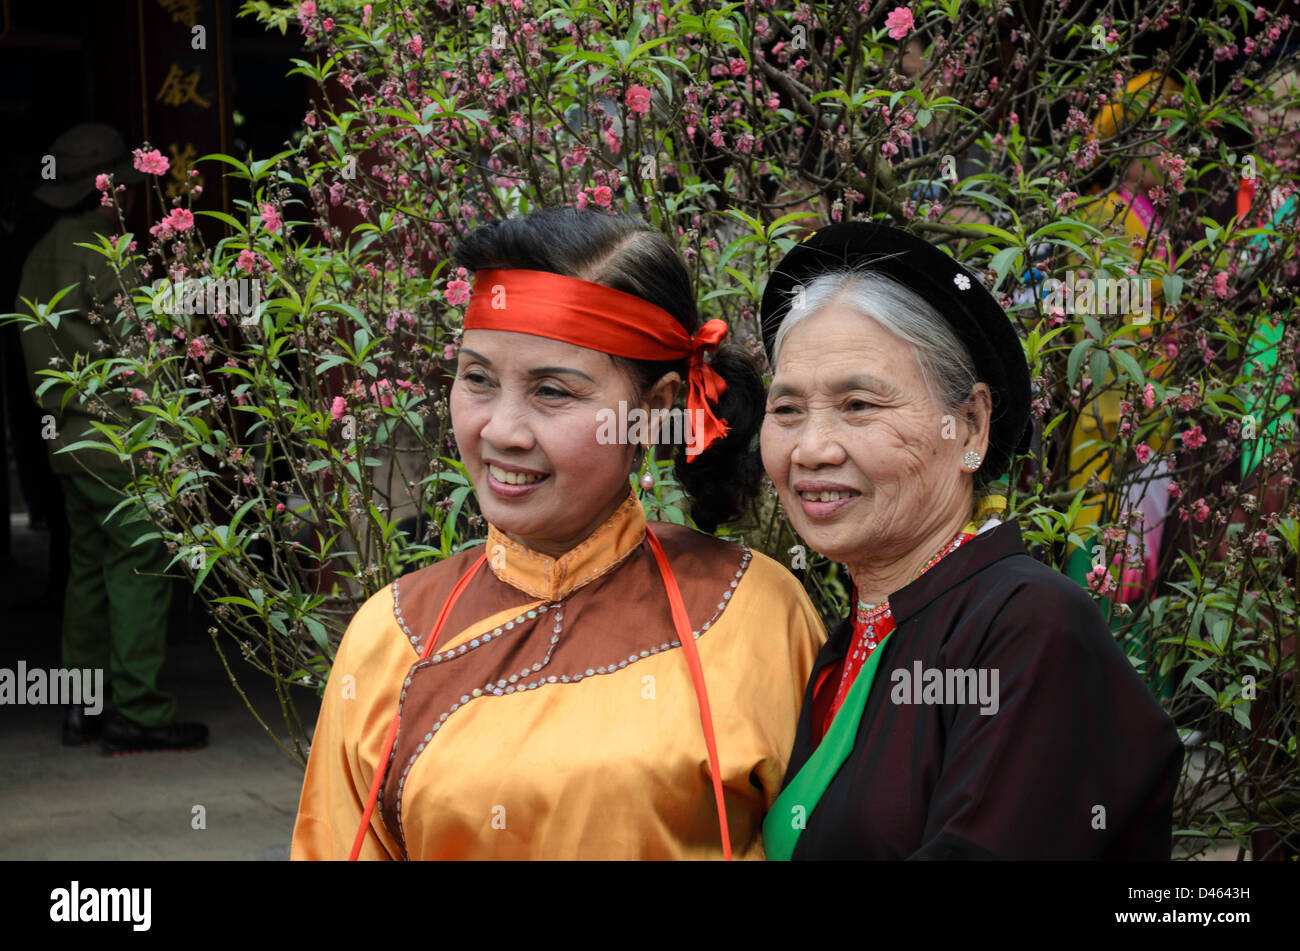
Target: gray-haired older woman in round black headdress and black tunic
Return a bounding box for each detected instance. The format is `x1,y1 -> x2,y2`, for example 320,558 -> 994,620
762,222 -> 1182,859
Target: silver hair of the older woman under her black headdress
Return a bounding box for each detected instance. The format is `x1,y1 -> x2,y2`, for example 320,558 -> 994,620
772,269 -> 979,412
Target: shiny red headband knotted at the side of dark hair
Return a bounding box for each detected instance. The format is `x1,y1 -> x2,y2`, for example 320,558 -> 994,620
464,268 -> 728,463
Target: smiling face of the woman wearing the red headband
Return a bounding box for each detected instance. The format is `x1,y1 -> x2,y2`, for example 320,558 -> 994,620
451,330 -> 636,556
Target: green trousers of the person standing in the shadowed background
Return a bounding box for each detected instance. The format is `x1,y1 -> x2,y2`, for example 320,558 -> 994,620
60,470 -> 176,726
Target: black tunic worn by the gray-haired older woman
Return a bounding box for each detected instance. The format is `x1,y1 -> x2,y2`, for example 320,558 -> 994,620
785,522 -> 1183,859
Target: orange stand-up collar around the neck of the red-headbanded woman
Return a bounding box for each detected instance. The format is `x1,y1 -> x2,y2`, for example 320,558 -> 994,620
488,487 -> 646,602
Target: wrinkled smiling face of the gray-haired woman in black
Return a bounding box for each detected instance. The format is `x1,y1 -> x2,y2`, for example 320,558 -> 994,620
762,305 -> 983,565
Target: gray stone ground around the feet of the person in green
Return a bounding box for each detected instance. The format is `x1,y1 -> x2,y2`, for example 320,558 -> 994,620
0,514 -> 317,860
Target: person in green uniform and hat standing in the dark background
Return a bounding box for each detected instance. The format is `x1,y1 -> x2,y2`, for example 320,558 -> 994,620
14,123 -> 208,754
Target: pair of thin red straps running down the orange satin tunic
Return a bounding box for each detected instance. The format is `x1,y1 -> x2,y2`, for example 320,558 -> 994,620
348,535 -> 732,861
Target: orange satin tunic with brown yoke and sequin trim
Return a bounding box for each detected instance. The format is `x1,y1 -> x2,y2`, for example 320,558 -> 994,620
291,495 -> 826,859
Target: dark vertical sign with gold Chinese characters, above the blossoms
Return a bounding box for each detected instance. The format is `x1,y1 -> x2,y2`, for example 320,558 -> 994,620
137,0 -> 234,240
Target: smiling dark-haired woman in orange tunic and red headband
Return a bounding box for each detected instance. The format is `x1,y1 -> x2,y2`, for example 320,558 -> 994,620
293,208 -> 826,859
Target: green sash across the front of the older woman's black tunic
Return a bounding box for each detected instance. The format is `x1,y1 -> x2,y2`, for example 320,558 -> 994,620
763,634 -> 884,861
